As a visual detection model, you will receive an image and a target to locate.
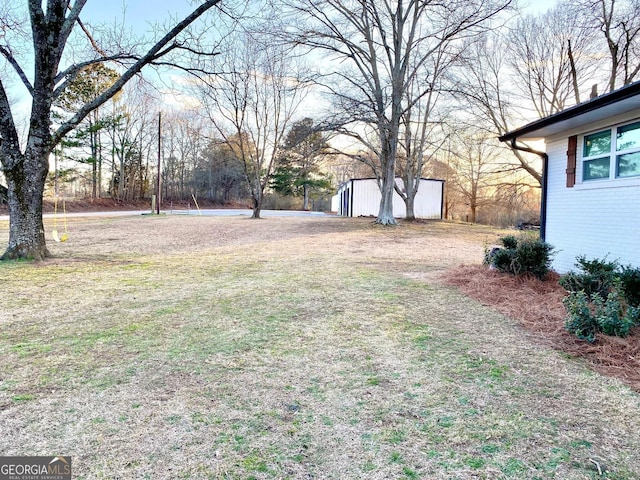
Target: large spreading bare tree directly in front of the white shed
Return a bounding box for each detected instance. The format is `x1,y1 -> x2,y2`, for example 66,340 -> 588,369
288,0 -> 510,225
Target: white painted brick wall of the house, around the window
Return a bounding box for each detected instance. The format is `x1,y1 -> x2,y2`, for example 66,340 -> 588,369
546,112 -> 640,273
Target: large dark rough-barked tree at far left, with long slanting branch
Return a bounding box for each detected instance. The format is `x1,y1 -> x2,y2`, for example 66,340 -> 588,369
0,0 -> 221,260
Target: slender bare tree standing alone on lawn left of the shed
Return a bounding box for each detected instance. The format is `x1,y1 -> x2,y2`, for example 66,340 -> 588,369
199,28 -> 308,218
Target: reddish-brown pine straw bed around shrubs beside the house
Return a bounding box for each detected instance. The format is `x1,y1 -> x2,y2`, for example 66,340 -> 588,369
444,265 -> 640,392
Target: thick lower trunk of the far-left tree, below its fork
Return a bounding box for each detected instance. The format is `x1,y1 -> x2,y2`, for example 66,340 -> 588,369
0,148 -> 49,260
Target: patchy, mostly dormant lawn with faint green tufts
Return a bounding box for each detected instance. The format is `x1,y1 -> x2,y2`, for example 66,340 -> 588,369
0,216 -> 640,480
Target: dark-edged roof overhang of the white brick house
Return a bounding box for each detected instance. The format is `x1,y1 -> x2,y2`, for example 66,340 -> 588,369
499,82 -> 640,142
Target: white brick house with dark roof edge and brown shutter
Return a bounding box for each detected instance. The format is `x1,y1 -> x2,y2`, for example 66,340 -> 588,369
500,82 -> 640,273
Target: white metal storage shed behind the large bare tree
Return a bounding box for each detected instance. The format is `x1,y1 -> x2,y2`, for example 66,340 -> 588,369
332,177 -> 444,219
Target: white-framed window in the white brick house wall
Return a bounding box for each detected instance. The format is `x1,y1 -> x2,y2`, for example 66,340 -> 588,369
582,121 -> 640,182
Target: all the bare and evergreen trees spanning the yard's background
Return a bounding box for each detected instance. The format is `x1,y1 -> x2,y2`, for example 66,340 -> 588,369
0,0 -> 640,258
